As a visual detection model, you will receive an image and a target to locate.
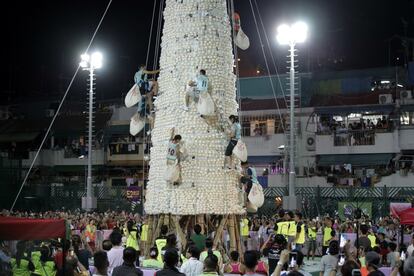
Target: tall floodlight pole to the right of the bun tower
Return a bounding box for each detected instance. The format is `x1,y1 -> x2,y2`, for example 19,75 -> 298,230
276,22 -> 308,210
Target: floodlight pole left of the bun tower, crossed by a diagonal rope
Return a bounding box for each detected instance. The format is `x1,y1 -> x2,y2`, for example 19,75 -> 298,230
79,52 -> 102,211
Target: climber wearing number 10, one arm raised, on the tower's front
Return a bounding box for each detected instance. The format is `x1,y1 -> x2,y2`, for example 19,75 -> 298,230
166,127 -> 182,185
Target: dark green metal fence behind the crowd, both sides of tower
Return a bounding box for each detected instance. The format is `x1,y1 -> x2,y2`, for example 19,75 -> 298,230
9,185 -> 414,218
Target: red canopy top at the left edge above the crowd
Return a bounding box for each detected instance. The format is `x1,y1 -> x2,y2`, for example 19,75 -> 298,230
0,217 -> 66,240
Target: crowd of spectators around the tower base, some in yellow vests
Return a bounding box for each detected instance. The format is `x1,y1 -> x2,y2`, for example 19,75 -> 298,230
0,210 -> 414,276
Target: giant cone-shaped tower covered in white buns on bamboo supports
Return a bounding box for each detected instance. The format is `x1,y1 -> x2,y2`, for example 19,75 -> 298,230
145,0 -> 245,254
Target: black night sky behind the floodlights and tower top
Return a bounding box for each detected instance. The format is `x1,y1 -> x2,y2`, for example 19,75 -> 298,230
0,0 -> 414,104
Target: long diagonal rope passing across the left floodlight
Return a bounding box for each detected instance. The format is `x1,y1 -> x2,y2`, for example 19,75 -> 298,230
10,0 -> 112,212
